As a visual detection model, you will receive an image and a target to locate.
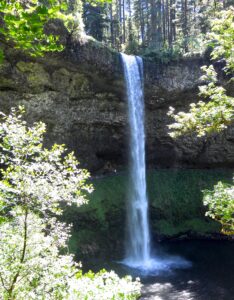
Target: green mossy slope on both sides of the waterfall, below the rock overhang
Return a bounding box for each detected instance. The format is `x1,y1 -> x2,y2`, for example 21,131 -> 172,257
65,170 -> 232,257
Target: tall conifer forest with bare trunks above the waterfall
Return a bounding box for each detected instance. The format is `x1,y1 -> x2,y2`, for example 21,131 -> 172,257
83,0 -> 233,55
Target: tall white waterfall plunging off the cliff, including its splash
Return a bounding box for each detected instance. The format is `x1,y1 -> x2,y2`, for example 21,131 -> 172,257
121,53 -> 190,274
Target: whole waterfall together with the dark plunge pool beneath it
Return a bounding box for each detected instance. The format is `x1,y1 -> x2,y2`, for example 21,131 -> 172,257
82,54 -> 234,300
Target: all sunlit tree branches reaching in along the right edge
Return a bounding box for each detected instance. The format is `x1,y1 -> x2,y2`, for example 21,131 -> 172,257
169,7 -> 234,233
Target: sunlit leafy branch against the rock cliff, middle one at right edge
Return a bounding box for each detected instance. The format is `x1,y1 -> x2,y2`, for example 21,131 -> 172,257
168,65 -> 234,138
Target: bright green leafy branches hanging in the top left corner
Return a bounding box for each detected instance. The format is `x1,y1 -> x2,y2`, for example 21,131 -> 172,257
0,0 -> 79,59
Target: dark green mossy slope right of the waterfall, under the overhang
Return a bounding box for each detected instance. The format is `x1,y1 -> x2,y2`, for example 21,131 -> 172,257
148,170 -> 229,237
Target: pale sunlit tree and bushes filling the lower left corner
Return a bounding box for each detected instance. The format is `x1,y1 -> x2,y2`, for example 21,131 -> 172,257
0,108 -> 140,300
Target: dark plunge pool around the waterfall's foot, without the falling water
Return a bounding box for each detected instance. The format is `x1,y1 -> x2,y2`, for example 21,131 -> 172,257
82,240 -> 234,300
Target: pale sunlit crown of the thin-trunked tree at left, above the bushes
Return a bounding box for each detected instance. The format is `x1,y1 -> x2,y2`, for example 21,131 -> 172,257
0,109 -> 92,213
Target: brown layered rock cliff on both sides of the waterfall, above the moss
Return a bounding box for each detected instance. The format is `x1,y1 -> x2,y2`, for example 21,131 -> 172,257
0,39 -> 234,171
